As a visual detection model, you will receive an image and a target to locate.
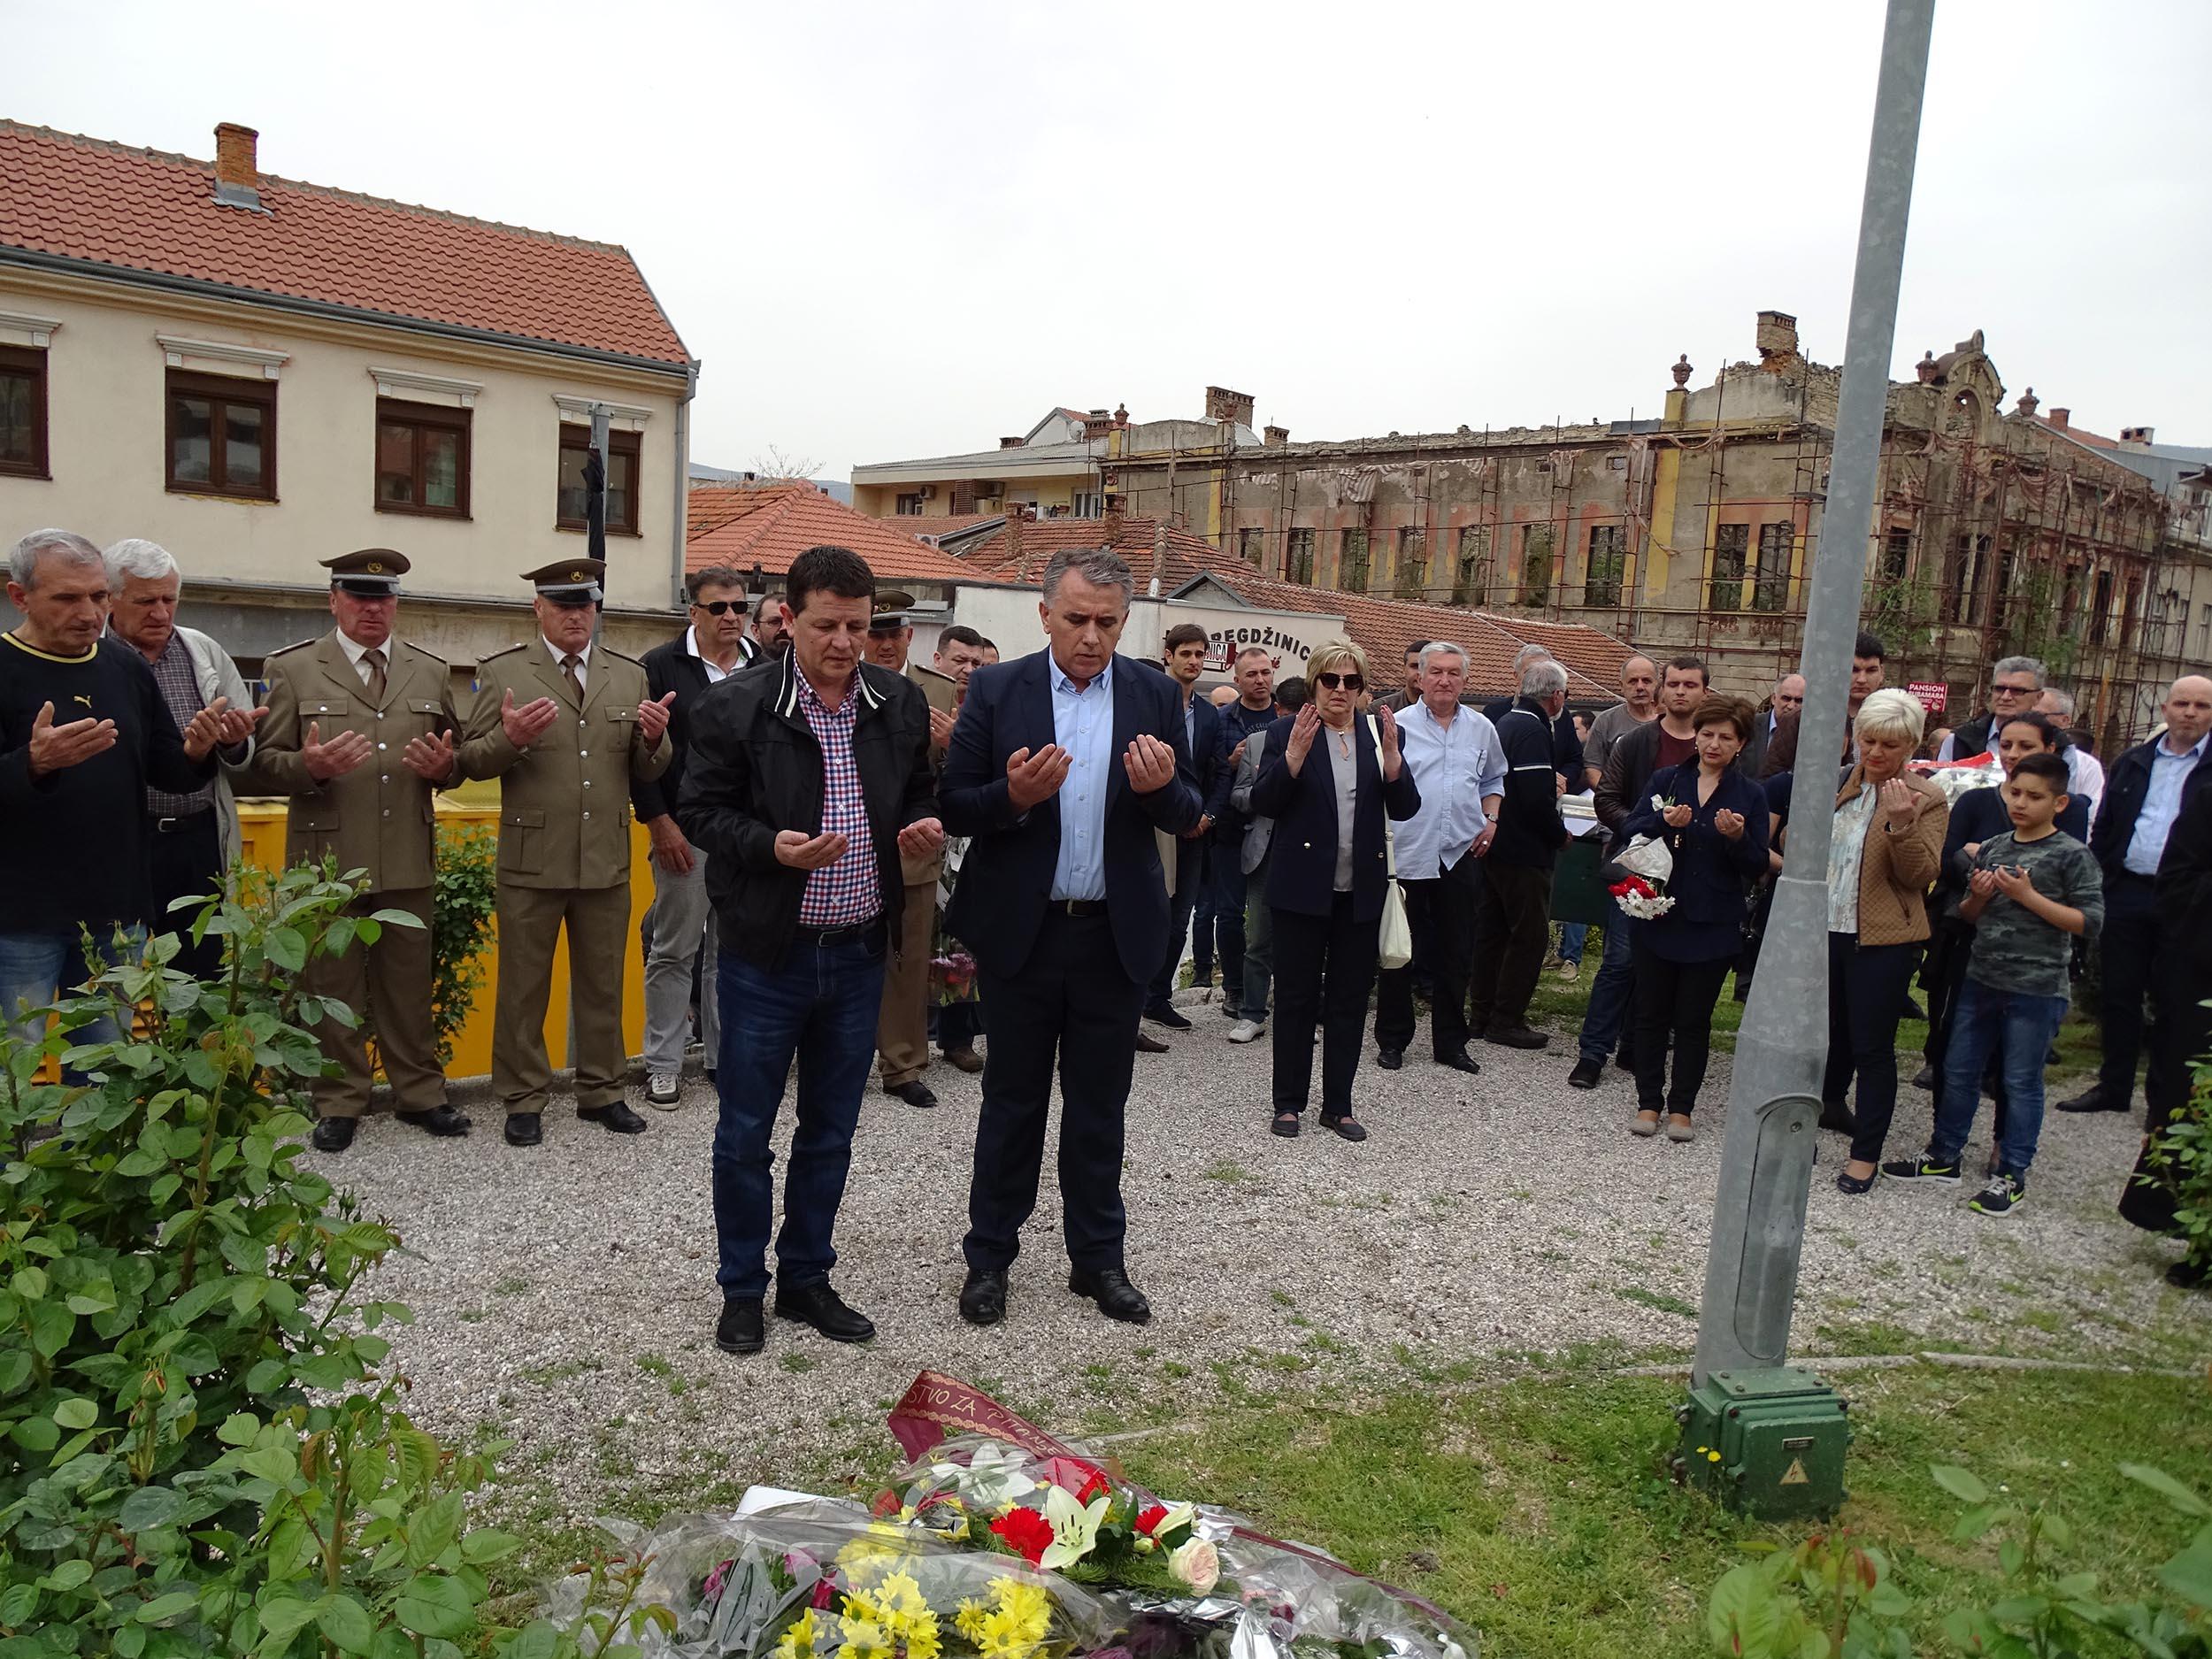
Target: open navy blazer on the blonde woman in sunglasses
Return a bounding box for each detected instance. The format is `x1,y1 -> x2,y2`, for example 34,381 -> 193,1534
1252,719 -> 1420,923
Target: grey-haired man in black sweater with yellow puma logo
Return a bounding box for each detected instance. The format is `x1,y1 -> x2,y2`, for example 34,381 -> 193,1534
0,529 -> 255,1042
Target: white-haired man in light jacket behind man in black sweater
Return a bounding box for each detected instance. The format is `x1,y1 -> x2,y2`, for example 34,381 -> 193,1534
106,538 -> 255,978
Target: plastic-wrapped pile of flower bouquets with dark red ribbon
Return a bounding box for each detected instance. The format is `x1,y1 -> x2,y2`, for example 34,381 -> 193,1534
547,1371 -> 1476,1659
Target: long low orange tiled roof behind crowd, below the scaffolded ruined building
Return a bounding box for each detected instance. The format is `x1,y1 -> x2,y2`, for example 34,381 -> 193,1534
1210,560 -> 1635,702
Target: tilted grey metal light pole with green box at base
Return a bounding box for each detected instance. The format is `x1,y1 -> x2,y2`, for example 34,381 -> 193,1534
1684,0 -> 1936,1513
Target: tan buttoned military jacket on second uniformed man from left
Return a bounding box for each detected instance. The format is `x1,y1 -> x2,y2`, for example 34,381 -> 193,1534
460,640 -> 675,889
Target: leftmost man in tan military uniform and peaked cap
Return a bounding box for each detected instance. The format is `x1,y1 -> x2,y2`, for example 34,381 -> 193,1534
237,547 -> 469,1153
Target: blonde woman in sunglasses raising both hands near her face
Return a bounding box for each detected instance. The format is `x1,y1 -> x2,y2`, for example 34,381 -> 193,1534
1252,640 -> 1420,1141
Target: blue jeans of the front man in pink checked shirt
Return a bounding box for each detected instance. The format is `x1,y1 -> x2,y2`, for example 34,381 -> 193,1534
712,932 -> 885,1299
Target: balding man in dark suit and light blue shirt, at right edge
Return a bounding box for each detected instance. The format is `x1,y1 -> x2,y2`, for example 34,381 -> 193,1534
2060,675 -> 2212,1113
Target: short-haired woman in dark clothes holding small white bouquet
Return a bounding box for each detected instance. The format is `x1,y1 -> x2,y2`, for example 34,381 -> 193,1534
1622,695 -> 1768,1141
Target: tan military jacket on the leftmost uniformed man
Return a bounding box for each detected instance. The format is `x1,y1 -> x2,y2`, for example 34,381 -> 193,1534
233,628 -> 463,892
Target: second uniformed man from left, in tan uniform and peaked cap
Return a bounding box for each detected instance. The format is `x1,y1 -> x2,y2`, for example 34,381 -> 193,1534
460,560 -> 675,1146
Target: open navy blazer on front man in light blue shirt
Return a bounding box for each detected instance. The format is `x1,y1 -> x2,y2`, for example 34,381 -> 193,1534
938,650 -> 1199,985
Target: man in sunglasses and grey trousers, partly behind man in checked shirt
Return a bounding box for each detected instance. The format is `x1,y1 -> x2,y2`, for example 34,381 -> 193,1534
631,565 -> 761,1113
